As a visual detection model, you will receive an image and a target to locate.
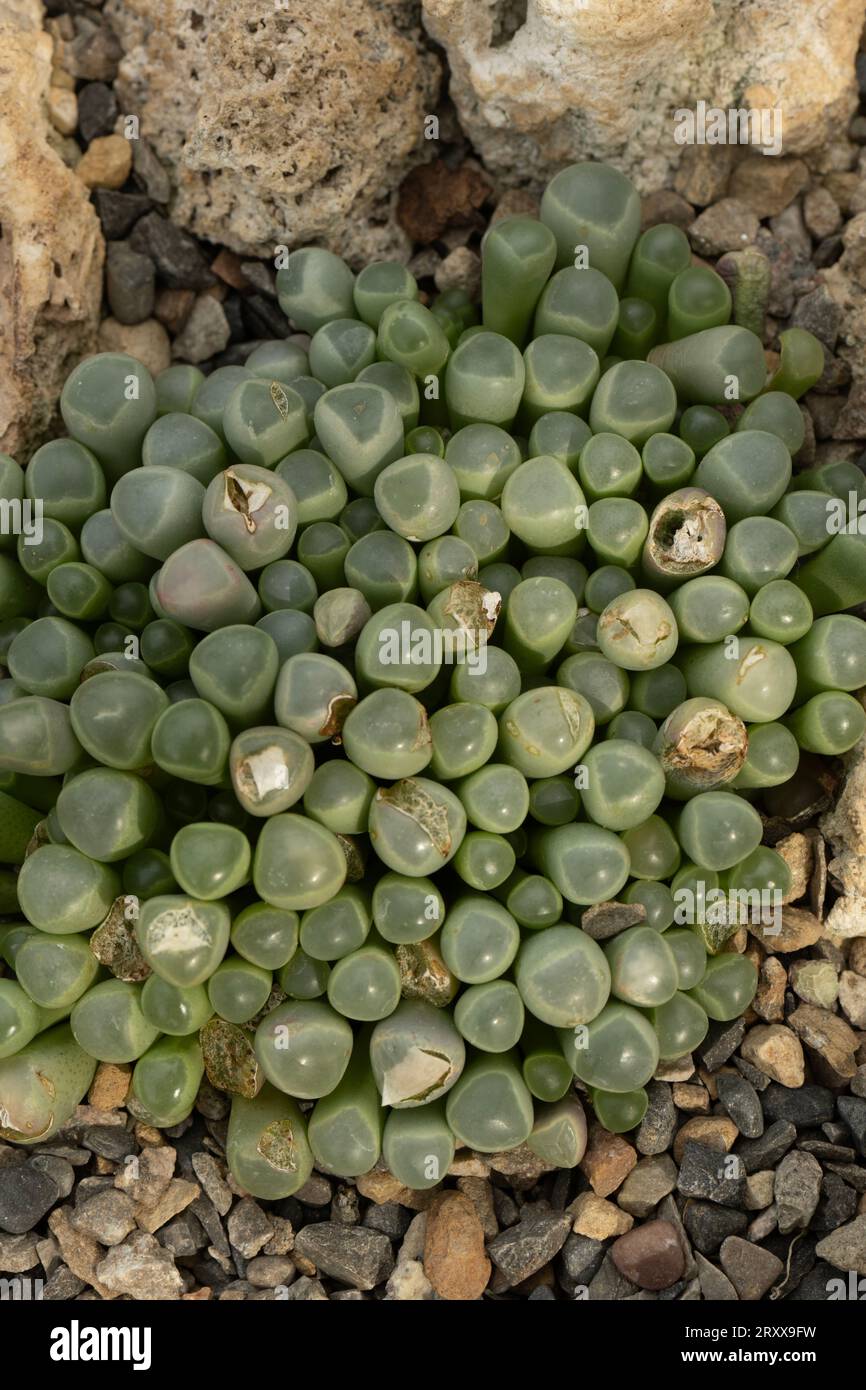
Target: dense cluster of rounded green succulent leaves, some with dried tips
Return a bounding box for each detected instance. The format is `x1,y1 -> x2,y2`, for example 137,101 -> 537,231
0,164 -> 866,1197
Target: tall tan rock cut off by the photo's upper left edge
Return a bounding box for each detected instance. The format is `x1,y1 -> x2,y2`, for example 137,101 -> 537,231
0,0 -> 103,464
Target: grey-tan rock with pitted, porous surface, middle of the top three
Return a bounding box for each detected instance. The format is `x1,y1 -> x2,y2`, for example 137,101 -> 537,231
106,0 -> 439,263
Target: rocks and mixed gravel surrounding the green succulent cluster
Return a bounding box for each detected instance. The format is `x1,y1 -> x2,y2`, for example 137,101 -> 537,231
0,0 -> 866,1301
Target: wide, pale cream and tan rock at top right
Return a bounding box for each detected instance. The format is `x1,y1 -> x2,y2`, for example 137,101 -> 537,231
423,0 -> 863,193
